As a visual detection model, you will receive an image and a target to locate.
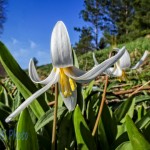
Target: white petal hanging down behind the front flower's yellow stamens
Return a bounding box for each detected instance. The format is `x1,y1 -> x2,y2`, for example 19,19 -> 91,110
60,90 -> 77,111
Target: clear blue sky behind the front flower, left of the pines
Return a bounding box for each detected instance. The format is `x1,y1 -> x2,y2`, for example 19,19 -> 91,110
1,0 -> 85,69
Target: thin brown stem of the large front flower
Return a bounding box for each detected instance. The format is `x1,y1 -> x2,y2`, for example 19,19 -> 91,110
51,83 -> 58,150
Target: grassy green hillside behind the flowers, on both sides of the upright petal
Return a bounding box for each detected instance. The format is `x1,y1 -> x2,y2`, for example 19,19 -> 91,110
37,37 -> 150,78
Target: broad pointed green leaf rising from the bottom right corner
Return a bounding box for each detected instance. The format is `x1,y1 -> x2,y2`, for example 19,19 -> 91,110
126,116 -> 150,150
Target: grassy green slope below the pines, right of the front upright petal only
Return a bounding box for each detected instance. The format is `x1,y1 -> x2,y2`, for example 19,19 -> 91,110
78,38 -> 150,71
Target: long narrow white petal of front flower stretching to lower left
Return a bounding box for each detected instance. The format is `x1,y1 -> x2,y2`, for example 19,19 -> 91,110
5,71 -> 59,122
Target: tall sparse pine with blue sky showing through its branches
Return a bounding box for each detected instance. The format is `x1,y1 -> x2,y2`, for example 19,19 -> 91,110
75,0 -> 110,49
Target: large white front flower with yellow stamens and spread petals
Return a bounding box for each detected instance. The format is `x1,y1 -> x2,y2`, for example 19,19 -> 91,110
5,21 -> 125,122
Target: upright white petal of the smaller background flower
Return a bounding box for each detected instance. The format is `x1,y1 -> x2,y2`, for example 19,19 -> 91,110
119,50 -> 131,69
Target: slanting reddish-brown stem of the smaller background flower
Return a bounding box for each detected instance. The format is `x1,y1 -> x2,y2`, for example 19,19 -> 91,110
92,76 -> 108,136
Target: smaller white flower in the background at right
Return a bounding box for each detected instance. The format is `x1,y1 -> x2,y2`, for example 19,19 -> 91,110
93,48 -> 150,80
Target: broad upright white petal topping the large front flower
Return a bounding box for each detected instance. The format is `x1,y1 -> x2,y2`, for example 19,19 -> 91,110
51,21 -> 73,68
